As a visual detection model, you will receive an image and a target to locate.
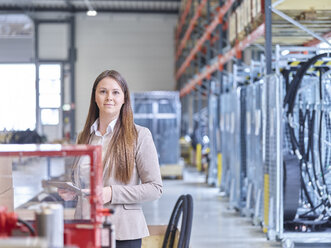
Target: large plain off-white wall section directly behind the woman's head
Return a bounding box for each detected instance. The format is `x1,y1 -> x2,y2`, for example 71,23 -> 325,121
76,14 -> 177,131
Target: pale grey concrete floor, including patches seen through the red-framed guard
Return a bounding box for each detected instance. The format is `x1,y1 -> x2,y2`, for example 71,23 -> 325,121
8,159 -> 331,248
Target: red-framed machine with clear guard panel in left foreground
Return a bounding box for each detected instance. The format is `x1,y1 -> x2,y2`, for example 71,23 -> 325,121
0,144 -> 115,247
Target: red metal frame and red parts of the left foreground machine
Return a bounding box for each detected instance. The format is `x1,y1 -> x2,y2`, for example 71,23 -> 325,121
0,145 -> 111,248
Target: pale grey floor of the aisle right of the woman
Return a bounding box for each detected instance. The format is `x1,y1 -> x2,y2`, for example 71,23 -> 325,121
143,169 -> 281,248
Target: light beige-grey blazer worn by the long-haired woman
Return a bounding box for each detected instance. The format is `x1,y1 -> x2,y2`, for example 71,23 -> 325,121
75,125 -> 162,240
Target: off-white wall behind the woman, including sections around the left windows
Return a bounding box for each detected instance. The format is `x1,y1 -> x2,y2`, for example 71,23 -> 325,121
0,13 -> 177,135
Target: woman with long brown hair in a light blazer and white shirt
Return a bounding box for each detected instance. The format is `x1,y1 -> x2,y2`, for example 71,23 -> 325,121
59,70 -> 162,248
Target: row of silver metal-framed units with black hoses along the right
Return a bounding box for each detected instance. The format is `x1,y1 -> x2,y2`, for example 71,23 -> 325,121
220,46 -> 331,247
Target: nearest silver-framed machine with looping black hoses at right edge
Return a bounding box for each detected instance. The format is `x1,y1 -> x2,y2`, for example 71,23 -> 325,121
267,46 -> 331,247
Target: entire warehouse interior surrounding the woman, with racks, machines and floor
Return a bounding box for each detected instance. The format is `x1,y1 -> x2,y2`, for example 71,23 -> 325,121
0,0 -> 331,248
